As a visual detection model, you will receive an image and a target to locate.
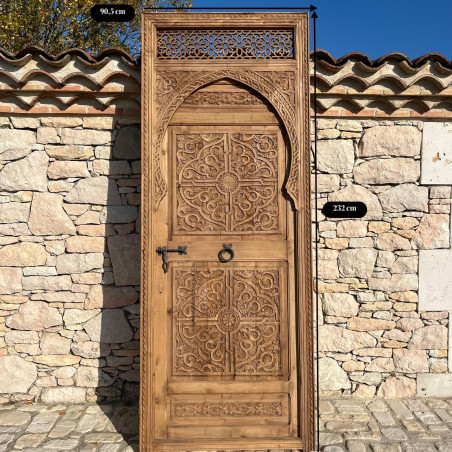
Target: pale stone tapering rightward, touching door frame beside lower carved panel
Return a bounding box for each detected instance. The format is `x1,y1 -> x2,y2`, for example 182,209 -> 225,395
319,325 -> 377,353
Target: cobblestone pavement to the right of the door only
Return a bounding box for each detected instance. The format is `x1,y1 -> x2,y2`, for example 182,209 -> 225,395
320,398 -> 452,452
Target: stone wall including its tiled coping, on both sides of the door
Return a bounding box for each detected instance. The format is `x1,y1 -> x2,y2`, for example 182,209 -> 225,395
0,49 -> 452,403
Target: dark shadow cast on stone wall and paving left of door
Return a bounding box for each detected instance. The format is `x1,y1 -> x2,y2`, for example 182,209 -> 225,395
94,121 -> 141,451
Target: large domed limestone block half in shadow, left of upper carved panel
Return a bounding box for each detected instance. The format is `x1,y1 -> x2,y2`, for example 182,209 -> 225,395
64,176 -> 121,206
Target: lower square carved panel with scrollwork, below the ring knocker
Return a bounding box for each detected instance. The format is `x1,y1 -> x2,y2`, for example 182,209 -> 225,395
173,263 -> 286,376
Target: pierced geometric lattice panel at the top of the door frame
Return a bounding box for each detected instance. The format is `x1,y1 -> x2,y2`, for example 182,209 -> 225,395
157,30 -> 294,60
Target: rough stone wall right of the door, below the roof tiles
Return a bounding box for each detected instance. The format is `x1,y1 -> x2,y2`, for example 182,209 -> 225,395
317,119 -> 452,397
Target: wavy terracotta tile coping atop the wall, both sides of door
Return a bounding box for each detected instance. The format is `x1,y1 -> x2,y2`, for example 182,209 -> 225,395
0,47 -> 452,119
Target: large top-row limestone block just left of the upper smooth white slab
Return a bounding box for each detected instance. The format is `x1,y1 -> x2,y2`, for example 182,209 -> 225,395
358,126 -> 422,157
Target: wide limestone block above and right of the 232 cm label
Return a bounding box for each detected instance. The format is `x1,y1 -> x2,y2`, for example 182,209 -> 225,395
353,158 -> 420,184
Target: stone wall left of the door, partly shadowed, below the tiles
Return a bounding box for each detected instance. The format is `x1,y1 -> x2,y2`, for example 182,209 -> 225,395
0,116 -> 141,403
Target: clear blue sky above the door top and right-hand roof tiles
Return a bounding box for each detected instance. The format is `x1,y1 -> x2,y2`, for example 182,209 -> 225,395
193,0 -> 452,59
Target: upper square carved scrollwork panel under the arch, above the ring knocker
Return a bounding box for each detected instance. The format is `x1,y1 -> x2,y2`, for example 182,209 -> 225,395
174,133 -> 282,234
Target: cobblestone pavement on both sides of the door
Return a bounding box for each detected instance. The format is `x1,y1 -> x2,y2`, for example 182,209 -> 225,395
0,398 -> 452,452
